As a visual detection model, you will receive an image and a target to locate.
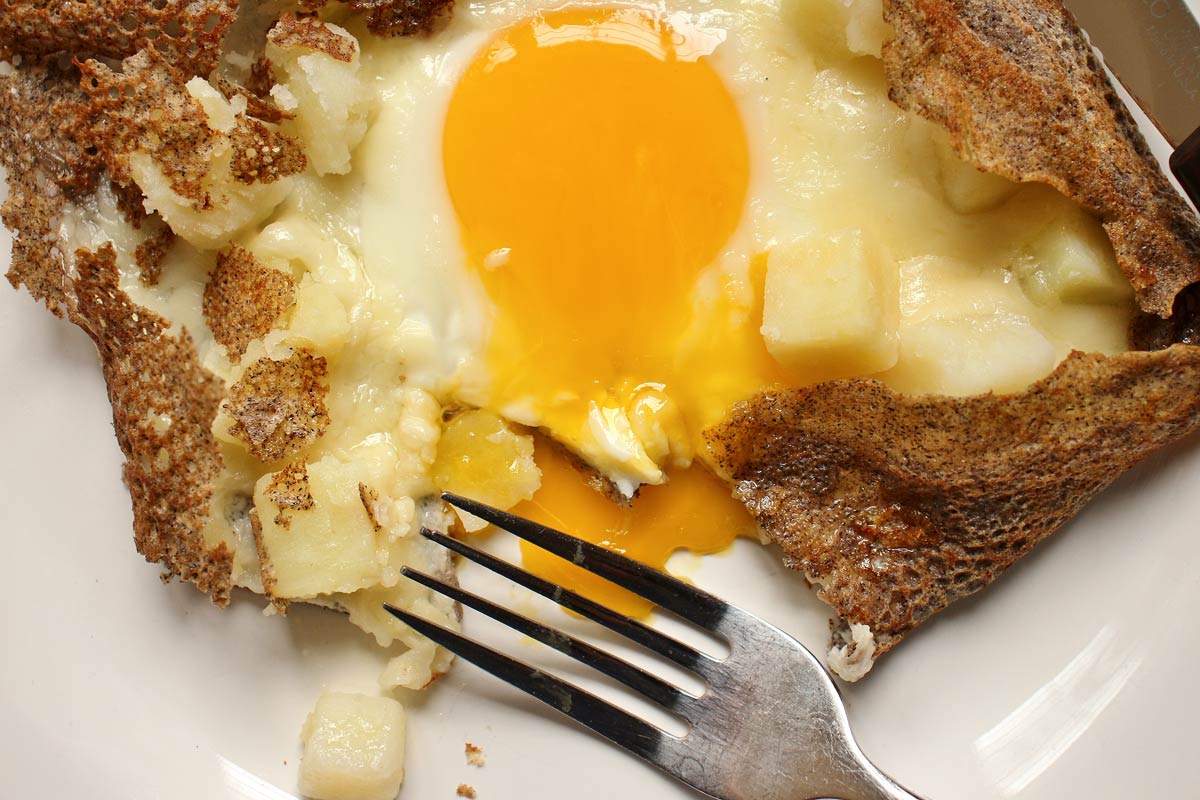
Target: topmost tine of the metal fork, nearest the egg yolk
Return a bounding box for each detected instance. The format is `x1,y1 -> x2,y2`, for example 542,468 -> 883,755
442,492 -> 728,630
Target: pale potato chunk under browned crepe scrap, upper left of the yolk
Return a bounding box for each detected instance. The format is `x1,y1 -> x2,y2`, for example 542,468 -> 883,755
266,23 -> 370,175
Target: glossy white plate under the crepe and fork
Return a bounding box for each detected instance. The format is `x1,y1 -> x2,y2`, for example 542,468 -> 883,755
0,9 -> 1200,800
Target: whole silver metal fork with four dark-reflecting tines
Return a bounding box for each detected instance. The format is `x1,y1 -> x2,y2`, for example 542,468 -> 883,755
386,494 -> 919,800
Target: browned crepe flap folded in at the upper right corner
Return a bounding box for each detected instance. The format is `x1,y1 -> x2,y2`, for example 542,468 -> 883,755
883,0 -> 1200,318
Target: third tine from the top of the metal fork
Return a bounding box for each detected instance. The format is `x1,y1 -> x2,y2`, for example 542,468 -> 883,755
401,566 -> 695,709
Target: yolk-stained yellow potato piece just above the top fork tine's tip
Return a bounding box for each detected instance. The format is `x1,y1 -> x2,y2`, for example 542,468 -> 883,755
433,410 -> 541,530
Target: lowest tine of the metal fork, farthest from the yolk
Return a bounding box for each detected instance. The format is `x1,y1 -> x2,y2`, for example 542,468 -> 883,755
384,603 -> 677,760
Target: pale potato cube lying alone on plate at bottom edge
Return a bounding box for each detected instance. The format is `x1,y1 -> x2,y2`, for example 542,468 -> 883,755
300,692 -> 404,800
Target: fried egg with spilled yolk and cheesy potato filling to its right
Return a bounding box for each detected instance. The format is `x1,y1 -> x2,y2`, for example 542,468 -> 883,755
343,0 -> 1130,609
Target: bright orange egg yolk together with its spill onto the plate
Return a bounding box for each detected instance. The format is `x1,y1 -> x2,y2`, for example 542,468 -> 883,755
443,7 -> 784,610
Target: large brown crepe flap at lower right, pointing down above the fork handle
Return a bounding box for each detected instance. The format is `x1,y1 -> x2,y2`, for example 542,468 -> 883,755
708,344 -> 1200,678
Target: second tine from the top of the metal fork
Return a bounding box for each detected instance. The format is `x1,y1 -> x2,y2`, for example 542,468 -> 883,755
421,528 -> 712,669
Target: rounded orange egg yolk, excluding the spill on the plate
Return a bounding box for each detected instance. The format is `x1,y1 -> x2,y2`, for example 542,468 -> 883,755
443,8 -> 749,417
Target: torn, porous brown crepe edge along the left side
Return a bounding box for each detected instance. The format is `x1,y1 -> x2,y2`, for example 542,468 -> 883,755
0,2 -> 292,604
